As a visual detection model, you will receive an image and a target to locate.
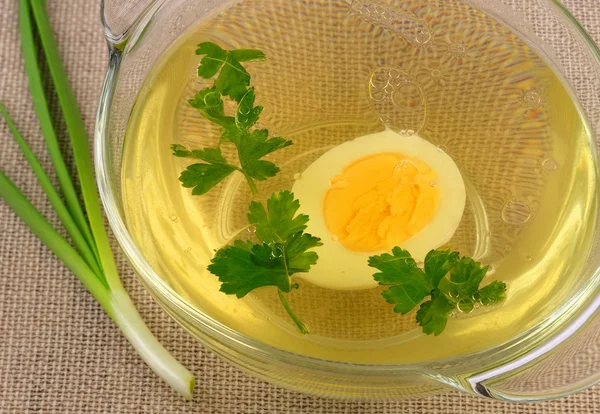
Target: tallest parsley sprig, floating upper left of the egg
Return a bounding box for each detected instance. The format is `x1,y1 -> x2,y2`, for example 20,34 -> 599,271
171,42 -> 292,195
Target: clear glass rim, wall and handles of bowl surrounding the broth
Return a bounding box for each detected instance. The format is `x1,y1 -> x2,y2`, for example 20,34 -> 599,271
94,0 -> 600,401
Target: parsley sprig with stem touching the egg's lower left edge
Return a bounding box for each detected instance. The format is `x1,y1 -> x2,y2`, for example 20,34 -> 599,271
208,191 -> 322,334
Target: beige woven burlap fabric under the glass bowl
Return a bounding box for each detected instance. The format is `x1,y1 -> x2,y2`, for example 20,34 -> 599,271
0,0 -> 600,414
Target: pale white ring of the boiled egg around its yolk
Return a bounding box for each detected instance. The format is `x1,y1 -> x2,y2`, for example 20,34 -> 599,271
292,129 -> 466,290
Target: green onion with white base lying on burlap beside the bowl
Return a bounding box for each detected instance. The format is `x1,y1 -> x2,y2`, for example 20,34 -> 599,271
0,0 -> 194,399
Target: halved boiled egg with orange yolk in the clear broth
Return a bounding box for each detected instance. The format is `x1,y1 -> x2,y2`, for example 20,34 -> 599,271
292,129 -> 466,290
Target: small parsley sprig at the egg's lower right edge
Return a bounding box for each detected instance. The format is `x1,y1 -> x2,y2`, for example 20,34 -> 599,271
369,247 -> 506,336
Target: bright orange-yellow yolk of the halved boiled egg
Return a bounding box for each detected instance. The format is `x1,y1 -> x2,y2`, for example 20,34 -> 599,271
323,153 -> 440,252
